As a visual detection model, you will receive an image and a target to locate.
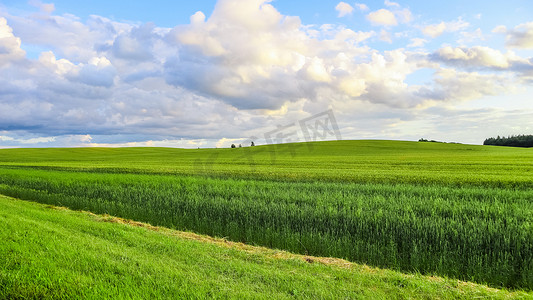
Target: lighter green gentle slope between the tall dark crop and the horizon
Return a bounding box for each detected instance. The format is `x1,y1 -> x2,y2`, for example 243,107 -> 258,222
0,140 -> 533,188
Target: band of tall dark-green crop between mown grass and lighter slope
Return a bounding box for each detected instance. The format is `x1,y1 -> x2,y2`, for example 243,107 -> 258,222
0,168 -> 533,289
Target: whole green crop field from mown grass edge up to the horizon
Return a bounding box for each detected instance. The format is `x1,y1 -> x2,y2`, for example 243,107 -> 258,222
0,141 -> 533,290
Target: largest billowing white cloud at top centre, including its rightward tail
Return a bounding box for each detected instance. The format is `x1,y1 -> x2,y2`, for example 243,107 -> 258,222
166,1 -> 462,110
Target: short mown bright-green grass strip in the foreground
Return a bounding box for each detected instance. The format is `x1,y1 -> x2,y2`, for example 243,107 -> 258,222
0,196 -> 533,299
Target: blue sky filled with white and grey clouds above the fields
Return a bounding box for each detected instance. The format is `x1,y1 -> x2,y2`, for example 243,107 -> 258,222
0,0 -> 533,148
